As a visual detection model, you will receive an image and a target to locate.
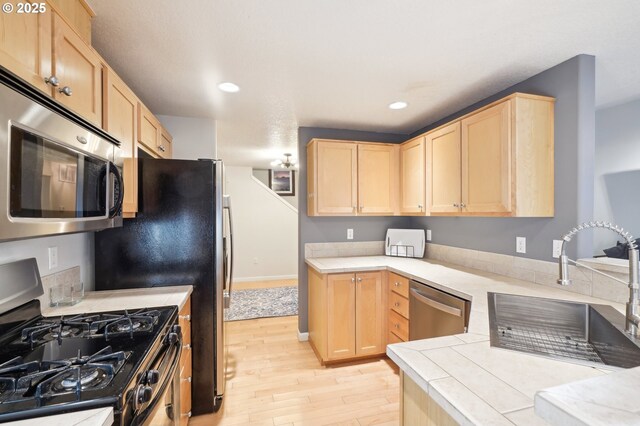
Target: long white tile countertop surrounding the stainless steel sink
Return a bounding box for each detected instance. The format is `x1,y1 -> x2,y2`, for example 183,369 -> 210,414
306,256 -> 640,425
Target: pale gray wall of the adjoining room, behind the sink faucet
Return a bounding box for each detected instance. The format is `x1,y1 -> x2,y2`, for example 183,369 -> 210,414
593,100 -> 640,254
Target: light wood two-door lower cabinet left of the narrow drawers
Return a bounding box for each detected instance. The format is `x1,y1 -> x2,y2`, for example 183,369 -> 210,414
309,268 -> 387,363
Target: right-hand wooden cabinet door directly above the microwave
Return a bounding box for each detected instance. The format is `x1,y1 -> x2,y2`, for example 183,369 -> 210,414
53,13 -> 102,126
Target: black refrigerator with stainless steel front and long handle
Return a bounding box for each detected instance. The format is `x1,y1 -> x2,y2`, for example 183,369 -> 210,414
95,158 -> 233,415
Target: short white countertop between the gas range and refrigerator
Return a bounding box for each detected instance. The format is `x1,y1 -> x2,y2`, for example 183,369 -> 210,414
42,285 -> 193,316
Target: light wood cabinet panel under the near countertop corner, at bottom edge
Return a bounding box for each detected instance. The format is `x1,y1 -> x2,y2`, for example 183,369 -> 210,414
400,371 -> 459,426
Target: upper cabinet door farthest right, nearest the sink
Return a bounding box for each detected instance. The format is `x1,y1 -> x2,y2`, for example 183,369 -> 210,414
462,101 -> 512,215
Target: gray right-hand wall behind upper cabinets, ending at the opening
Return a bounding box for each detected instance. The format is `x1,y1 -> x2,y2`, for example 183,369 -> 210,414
411,55 -> 597,260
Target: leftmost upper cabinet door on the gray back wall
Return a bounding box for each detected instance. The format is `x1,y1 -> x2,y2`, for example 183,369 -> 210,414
316,141 -> 358,216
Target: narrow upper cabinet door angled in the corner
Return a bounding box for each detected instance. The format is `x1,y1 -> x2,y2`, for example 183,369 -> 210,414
400,136 -> 425,213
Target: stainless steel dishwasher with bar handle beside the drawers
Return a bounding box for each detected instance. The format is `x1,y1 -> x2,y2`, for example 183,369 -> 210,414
409,280 -> 471,340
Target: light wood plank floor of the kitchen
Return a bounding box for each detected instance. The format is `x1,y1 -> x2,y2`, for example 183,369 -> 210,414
189,316 -> 399,426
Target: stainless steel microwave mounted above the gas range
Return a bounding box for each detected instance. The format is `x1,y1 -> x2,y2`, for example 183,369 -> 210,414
0,71 -> 124,241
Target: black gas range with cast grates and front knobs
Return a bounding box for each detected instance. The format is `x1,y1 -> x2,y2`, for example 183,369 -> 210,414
0,258 -> 182,425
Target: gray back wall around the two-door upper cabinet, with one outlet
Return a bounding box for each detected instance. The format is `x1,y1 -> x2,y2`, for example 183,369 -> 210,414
296,127 -> 409,332
